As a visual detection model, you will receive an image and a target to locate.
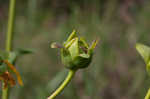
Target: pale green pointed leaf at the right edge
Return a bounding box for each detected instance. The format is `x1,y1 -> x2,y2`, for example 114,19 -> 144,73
136,43 -> 150,64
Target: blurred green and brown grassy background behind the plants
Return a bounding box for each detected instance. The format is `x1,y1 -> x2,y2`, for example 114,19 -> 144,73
0,0 -> 150,99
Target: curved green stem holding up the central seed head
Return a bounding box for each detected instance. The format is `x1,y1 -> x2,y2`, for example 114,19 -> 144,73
47,70 -> 76,99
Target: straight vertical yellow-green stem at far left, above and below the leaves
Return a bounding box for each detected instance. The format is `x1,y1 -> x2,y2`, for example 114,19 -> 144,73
2,0 -> 16,99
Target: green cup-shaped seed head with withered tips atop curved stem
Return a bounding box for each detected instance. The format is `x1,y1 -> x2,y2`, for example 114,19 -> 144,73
51,31 -> 98,70
